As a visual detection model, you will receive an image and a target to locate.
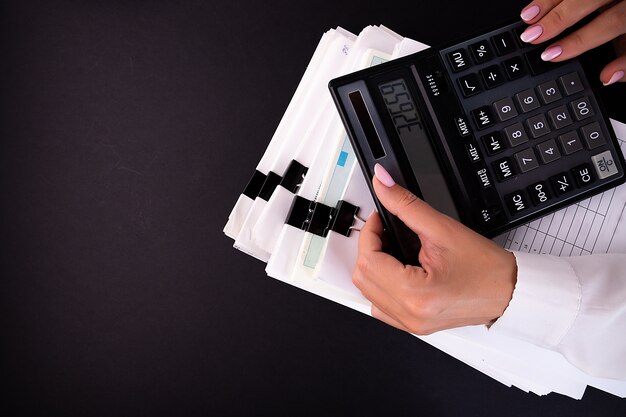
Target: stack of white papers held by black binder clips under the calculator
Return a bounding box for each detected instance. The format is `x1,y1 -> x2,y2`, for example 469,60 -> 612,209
224,26 -> 626,398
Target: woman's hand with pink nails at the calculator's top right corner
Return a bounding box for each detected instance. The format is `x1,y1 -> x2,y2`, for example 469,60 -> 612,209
521,0 -> 626,85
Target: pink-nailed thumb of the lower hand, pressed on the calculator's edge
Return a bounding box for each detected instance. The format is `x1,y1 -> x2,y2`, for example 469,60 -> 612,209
373,164 -> 447,236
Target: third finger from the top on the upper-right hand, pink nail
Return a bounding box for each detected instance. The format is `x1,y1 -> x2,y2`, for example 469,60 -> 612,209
541,2 -> 626,62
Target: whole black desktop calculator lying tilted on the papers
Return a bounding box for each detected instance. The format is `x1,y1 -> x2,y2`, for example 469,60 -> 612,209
329,22 -> 625,264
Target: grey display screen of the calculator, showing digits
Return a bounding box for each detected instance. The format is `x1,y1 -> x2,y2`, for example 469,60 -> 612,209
378,78 -> 459,219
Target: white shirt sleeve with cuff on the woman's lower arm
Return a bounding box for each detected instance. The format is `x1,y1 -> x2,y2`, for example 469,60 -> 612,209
490,252 -> 626,380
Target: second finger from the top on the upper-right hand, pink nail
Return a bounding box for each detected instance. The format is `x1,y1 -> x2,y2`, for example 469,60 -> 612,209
521,0 -> 611,44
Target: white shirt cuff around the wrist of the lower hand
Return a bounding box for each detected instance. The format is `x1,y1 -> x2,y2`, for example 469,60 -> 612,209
490,252 -> 581,348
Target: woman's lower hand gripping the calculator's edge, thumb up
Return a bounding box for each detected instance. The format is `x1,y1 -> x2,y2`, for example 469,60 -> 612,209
352,165 -> 517,334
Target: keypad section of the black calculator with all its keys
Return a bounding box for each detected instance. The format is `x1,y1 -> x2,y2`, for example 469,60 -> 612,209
442,25 -> 619,227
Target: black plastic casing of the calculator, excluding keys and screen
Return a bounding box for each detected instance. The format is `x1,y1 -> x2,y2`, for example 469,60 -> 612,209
329,18 -> 626,265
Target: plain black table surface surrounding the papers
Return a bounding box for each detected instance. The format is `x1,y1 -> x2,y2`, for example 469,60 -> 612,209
0,0 -> 626,417
